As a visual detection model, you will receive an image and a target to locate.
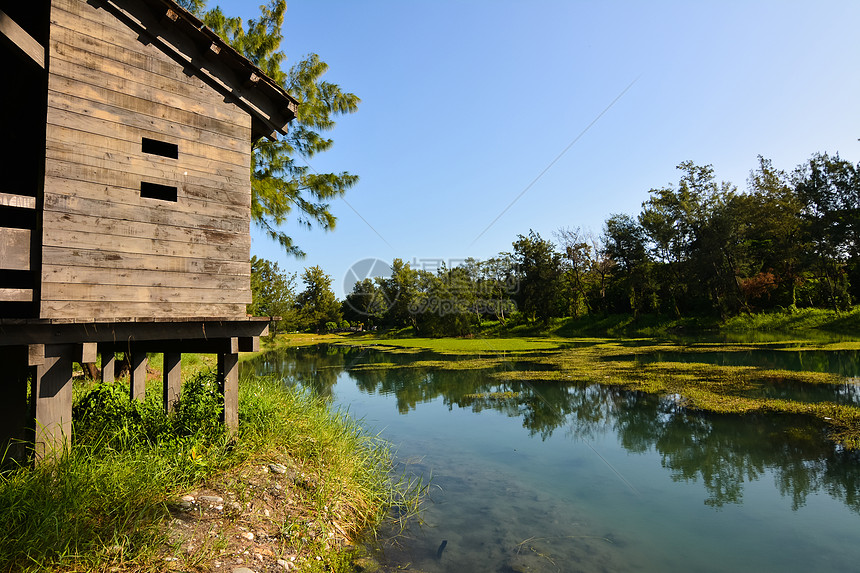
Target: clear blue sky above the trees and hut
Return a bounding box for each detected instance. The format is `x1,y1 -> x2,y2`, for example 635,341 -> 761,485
209,0 -> 860,299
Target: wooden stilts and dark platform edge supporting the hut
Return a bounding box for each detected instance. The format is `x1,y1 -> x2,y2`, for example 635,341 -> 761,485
0,318 -> 265,456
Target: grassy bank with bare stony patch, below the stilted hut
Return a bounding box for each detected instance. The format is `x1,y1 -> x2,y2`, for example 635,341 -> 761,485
0,373 -> 417,572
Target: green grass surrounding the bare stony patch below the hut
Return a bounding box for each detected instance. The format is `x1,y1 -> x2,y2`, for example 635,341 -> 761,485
0,373 -> 417,571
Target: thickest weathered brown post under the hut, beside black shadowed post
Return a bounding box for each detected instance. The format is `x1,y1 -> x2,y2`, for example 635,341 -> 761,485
32,344 -> 75,462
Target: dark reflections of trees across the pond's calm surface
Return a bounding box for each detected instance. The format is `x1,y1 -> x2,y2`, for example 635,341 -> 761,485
244,346 -> 860,512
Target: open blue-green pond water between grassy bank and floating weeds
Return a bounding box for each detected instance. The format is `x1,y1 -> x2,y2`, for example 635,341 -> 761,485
243,346 -> 860,572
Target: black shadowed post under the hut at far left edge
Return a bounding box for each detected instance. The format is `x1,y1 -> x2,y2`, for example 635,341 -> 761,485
0,346 -> 31,461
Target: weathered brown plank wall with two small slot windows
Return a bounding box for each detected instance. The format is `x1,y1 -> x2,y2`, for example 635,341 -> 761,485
40,0 -> 251,319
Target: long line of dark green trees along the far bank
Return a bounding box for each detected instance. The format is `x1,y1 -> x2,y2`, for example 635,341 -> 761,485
249,154 -> 860,336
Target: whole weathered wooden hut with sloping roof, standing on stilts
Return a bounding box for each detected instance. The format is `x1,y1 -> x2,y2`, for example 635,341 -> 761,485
0,0 -> 296,455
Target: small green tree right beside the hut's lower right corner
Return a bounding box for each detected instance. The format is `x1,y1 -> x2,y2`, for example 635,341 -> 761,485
247,257 -> 298,334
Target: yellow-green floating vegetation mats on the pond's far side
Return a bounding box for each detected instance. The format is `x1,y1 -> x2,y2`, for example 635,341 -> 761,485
361,339 -> 860,449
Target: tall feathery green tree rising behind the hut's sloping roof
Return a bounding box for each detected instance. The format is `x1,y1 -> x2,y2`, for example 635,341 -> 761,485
180,0 -> 360,257
